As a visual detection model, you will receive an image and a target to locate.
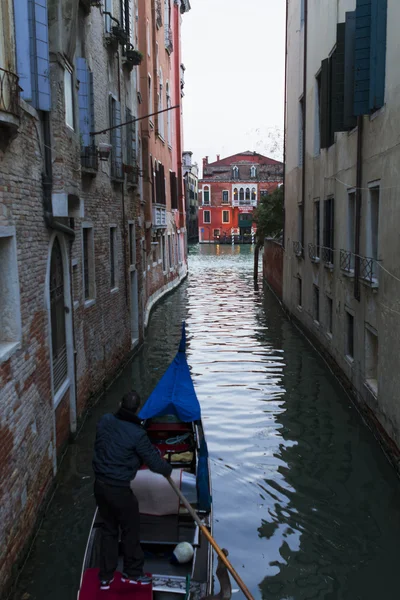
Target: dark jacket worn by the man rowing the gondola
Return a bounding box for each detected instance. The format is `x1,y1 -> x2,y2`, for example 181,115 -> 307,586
92,409 -> 172,486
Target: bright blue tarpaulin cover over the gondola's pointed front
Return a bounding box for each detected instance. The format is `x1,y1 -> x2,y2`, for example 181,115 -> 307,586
139,323 -> 201,423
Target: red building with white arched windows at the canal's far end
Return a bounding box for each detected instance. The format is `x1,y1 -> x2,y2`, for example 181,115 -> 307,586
199,152 -> 283,243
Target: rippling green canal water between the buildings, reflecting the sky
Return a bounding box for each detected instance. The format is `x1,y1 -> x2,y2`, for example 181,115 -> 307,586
14,246 -> 400,600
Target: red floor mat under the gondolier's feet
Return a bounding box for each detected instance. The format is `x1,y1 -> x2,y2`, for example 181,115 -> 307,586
78,569 -> 153,600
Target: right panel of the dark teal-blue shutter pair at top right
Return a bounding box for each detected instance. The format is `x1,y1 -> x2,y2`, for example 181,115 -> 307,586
369,0 -> 387,111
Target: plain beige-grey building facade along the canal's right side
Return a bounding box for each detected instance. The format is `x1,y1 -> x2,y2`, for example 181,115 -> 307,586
283,0 -> 400,465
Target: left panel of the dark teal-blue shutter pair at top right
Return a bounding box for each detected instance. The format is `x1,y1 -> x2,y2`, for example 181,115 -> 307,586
354,0 -> 371,116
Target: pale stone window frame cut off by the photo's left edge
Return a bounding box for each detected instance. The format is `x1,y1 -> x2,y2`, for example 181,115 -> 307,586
0,226 -> 22,363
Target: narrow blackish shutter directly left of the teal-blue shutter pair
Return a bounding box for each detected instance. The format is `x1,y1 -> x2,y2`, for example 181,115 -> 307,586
343,11 -> 357,131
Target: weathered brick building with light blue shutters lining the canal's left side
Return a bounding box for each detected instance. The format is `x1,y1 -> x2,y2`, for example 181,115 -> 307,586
0,0 -> 187,595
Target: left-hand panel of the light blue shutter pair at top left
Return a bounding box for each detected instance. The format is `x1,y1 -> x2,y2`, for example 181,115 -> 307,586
14,0 -> 32,102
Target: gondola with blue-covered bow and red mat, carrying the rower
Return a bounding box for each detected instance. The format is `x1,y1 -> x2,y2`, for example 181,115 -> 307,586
78,324 -> 213,600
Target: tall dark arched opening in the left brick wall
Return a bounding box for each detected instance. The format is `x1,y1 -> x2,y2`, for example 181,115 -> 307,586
50,238 -> 68,393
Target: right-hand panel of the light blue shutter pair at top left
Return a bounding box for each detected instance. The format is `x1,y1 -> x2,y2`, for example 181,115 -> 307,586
31,0 -> 51,111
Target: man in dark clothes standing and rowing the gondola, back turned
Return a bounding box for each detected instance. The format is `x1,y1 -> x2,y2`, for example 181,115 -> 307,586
93,390 -> 172,590
